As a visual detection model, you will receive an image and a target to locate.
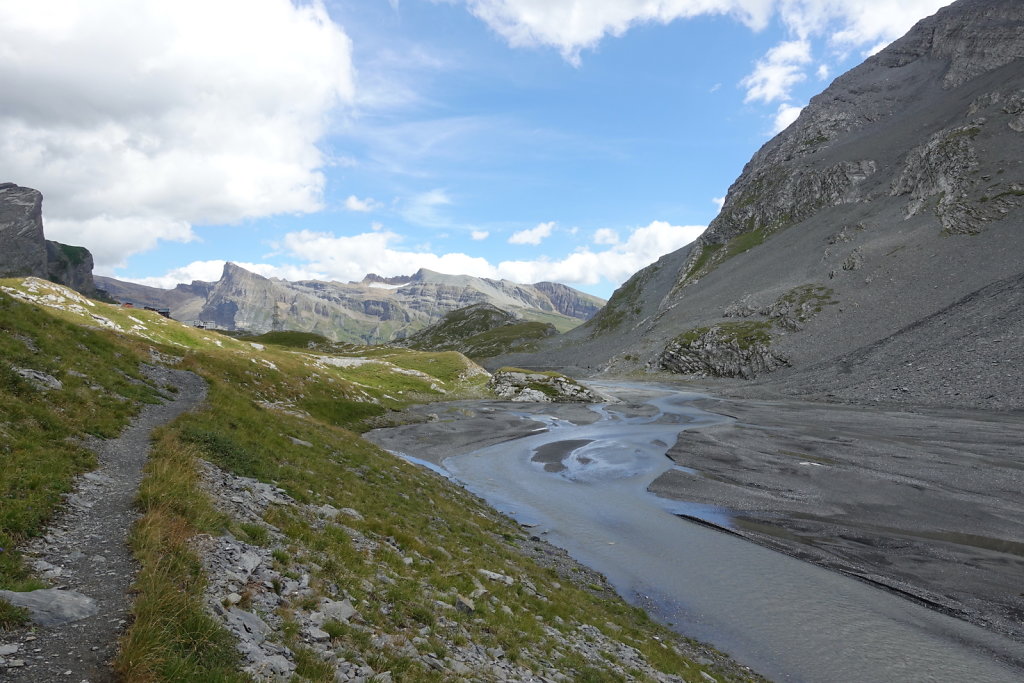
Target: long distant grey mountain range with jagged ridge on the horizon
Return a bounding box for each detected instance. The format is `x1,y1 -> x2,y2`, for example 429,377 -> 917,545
97,263 -> 604,343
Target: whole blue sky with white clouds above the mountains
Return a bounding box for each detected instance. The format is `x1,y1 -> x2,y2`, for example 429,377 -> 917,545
0,0 -> 947,298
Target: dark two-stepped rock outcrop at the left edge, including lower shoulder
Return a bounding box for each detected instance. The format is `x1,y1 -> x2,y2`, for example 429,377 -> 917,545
0,182 -> 98,296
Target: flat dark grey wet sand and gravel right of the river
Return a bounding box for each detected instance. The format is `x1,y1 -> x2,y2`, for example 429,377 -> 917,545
650,399 -> 1024,651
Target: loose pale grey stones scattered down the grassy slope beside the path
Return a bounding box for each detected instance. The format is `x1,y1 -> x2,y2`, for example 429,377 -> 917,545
197,464 -> 751,682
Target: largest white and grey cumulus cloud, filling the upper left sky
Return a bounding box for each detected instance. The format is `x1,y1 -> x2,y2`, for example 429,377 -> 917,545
0,0 -> 353,266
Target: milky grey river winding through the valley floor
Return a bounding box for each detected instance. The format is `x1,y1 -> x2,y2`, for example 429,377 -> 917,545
434,383 -> 1024,683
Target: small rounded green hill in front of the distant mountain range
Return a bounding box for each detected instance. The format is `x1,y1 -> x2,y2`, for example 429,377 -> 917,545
398,303 -> 567,358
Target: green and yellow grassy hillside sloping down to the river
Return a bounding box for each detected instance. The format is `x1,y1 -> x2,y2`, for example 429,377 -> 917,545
0,279 -> 761,681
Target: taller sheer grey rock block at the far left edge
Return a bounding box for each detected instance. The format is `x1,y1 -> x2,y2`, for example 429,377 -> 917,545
0,182 -> 47,278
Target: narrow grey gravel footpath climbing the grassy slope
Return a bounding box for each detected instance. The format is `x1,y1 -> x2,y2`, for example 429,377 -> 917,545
0,367 -> 206,683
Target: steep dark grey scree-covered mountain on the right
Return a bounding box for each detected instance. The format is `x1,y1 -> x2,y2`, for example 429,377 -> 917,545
495,0 -> 1024,409
